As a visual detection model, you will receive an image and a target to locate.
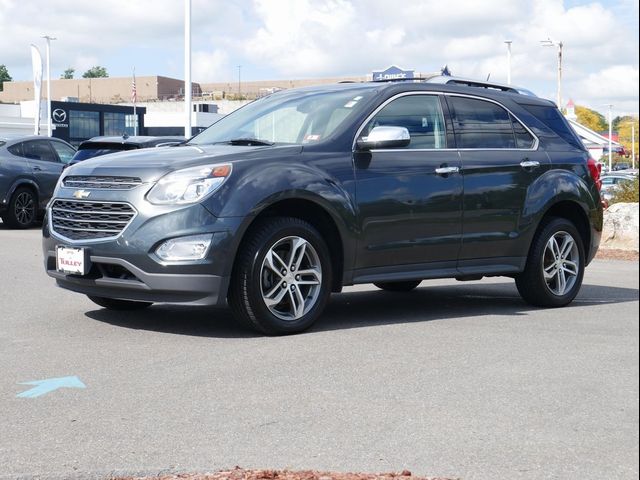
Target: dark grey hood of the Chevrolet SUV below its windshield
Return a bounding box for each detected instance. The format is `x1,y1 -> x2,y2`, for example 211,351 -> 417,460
65,144 -> 302,183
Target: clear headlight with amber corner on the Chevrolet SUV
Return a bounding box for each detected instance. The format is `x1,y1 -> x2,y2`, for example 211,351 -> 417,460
147,163 -> 231,205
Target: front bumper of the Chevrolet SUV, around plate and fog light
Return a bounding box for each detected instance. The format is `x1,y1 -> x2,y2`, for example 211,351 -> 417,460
42,197 -> 242,305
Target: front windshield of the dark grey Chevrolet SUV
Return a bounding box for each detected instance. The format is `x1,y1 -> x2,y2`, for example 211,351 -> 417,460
189,87 -> 375,145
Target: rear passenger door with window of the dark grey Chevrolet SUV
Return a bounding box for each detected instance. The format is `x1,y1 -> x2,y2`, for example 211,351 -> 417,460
446,95 -> 549,269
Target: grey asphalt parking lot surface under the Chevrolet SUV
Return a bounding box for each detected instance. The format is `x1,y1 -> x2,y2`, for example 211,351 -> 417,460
0,224 -> 638,479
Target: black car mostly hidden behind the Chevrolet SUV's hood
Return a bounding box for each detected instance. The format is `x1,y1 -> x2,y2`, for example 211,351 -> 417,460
70,135 -> 185,165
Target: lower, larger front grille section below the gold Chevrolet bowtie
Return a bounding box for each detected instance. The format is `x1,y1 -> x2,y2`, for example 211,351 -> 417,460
51,200 -> 136,240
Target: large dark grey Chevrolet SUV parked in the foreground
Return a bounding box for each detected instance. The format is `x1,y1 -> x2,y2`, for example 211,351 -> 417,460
43,79 -> 602,334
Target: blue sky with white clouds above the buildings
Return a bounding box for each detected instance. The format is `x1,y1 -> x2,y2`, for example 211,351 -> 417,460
0,0 -> 639,116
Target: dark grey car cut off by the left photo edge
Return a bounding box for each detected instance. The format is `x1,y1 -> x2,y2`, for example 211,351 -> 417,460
0,135 -> 76,228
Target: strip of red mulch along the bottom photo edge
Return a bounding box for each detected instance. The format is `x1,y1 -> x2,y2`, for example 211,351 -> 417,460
112,467 -> 453,480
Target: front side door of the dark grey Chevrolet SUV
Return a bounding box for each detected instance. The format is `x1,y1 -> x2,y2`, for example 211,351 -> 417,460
354,93 -> 462,276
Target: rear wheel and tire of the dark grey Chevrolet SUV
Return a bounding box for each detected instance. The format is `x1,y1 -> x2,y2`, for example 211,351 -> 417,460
516,217 -> 585,308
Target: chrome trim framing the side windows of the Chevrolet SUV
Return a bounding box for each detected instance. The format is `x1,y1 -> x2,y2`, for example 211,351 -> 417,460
351,90 -> 540,153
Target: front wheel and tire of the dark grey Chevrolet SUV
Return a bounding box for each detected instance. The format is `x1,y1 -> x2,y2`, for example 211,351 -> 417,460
228,217 -> 332,335
